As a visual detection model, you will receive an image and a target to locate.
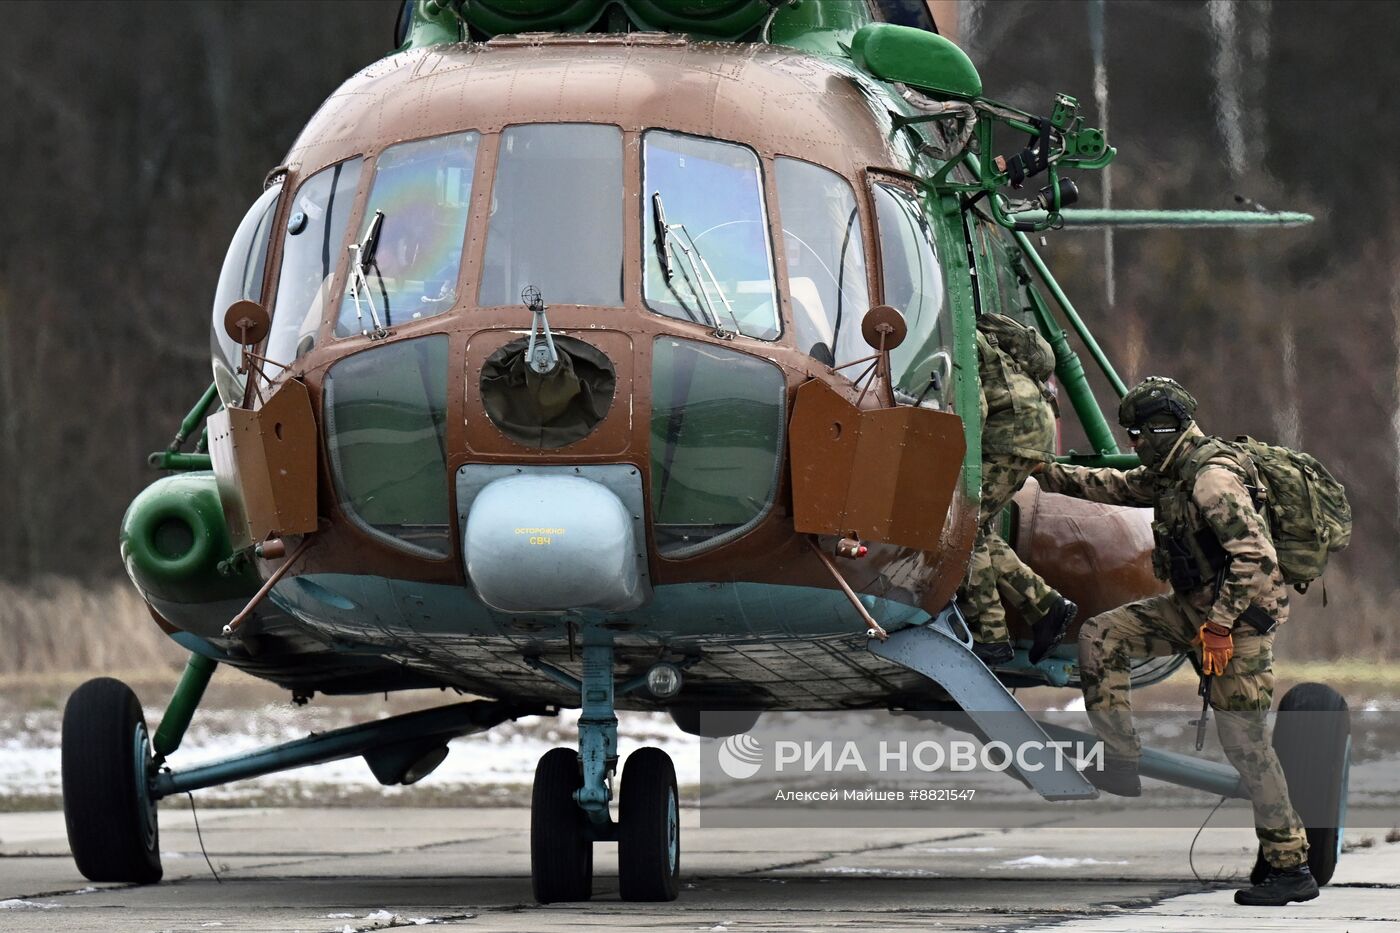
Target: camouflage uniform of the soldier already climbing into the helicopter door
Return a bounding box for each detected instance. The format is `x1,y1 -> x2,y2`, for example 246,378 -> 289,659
960,331 -> 1058,644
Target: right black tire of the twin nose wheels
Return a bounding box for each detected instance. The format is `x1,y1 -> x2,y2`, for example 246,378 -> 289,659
617,748 -> 680,901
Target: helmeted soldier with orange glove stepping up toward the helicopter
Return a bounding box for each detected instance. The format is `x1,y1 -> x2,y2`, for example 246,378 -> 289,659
1040,377 -> 1317,905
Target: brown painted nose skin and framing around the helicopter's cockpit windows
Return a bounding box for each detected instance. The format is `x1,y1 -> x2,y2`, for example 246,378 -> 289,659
238,35 -> 976,611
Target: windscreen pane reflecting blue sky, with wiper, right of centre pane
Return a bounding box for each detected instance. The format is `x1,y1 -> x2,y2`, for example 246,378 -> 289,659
641,130 -> 781,340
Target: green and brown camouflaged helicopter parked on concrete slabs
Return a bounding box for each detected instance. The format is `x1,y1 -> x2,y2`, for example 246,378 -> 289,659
62,0 -> 1347,902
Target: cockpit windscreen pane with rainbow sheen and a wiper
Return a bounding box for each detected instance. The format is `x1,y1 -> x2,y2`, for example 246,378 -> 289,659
335,132 -> 480,336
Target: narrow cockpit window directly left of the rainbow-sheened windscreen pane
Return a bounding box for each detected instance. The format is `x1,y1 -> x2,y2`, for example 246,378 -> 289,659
266,157 -> 364,364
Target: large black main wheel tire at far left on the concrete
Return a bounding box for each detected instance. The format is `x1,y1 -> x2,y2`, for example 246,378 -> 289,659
63,677 -> 162,884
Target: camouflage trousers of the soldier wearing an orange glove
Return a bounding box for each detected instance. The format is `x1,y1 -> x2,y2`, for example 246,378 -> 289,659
1079,594 -> 1308,869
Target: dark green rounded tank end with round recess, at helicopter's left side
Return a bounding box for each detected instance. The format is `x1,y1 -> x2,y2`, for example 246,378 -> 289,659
122,472 -> 262,605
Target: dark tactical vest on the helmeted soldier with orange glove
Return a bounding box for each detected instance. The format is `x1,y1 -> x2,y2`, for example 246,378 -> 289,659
1152,437 -> 1267,593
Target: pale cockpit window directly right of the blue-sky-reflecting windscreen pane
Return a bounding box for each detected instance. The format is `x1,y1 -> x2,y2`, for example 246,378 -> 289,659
774,158 -> 871,366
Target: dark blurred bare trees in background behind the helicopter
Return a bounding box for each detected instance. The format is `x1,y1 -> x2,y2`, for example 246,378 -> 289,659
0,0 -> 1400,653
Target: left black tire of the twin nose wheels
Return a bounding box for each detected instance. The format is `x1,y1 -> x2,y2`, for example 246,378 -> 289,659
529,748 -> 594,904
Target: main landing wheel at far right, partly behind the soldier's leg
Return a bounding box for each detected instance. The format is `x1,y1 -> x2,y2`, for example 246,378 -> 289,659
1249,684 -> 1351,884
